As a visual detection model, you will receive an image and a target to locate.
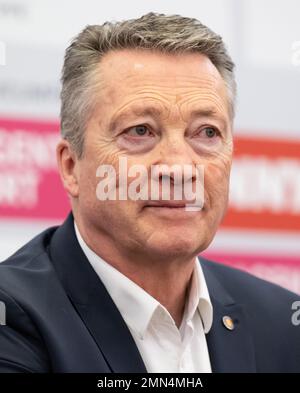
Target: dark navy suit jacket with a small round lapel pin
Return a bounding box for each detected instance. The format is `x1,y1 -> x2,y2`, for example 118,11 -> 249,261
0,214 -> 300,373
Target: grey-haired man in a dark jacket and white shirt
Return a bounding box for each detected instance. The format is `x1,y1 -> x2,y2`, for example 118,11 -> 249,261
0,13 -> 300,372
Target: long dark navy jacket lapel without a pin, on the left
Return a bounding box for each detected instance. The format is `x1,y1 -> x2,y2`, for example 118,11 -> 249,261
49,213 -> 146,373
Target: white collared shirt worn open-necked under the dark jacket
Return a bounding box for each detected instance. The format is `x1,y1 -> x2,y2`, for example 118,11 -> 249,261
74,222 -> 213,373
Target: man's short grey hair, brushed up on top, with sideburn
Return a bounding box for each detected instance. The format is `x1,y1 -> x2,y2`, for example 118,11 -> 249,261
61,12 -> 236,158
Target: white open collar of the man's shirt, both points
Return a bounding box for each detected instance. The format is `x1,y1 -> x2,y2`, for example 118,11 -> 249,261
74,221 -> 213,337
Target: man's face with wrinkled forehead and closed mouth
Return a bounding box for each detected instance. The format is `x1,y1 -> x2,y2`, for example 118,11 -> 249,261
76,50 -> 232,258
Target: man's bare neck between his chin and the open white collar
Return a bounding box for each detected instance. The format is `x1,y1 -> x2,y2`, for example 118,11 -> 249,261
76,216 -> 195,327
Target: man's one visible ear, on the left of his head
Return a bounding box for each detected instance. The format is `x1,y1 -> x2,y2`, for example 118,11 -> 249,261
56,139 -> 79,198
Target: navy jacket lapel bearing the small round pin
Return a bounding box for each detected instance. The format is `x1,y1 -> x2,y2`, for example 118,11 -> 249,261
200,258 -> 256,373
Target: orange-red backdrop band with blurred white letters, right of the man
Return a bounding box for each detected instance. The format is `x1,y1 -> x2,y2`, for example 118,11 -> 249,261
222,136 -> 300,231
